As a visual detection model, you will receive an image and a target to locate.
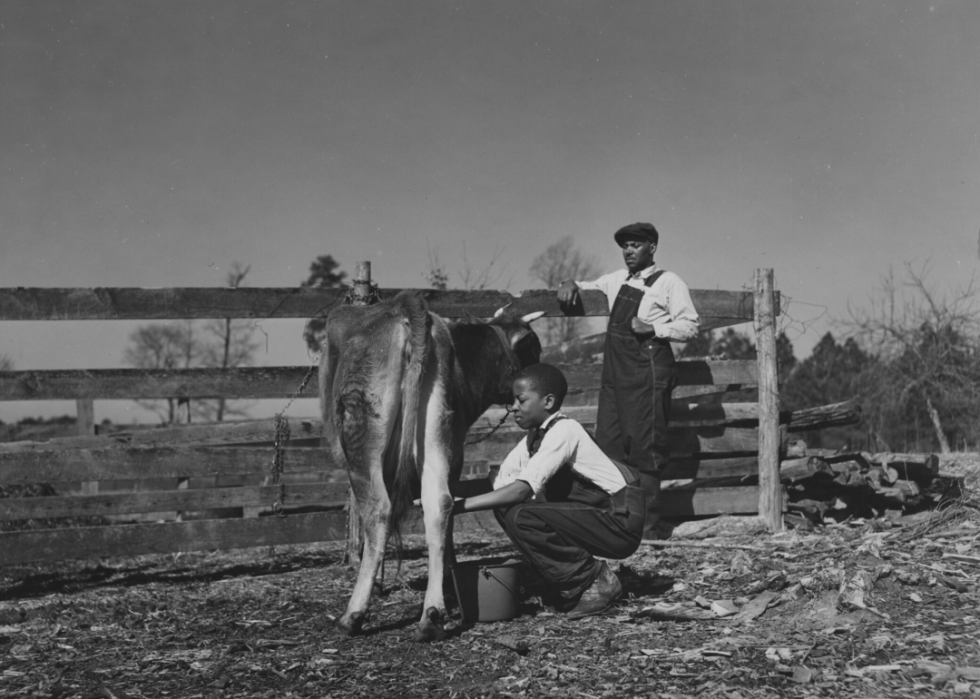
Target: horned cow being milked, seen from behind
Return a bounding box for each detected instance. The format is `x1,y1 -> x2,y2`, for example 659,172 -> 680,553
319,291 -> 544,641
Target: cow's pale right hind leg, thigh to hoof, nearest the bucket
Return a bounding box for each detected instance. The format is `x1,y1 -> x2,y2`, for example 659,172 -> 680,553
415,380 -> 453,641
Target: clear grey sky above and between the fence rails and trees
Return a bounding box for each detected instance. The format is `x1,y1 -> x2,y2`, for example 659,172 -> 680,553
0,0 -> 980,422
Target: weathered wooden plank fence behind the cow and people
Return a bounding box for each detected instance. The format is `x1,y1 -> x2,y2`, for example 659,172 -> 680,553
0,270 -> 804,565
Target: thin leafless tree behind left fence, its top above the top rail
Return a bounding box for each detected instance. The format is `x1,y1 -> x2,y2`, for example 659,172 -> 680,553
196,262 -> 260,422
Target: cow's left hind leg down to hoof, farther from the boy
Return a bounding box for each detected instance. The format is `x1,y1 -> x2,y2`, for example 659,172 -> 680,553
337,467 -> 391,636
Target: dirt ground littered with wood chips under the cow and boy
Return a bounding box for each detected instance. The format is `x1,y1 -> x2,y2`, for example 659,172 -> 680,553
0,462 -> 980,699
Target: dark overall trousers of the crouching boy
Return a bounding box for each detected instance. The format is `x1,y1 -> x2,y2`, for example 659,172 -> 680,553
494,482 -> 646,608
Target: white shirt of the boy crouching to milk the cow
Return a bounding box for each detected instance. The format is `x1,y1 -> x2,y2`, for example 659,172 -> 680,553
493,412 -> 626,501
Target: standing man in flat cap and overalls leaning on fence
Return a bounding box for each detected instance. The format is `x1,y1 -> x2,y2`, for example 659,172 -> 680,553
558,223 -> 700,539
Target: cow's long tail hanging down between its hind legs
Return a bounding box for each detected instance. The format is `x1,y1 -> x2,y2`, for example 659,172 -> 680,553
389,294 -> 432,548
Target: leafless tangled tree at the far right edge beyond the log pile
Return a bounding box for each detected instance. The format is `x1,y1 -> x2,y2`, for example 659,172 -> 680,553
848,264 -> 980,453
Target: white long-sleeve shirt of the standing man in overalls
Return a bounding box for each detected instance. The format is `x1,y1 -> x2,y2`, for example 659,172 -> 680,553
575,265 -> 701,342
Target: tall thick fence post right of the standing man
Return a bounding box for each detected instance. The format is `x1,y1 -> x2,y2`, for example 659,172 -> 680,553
755,269 -> 783,533
